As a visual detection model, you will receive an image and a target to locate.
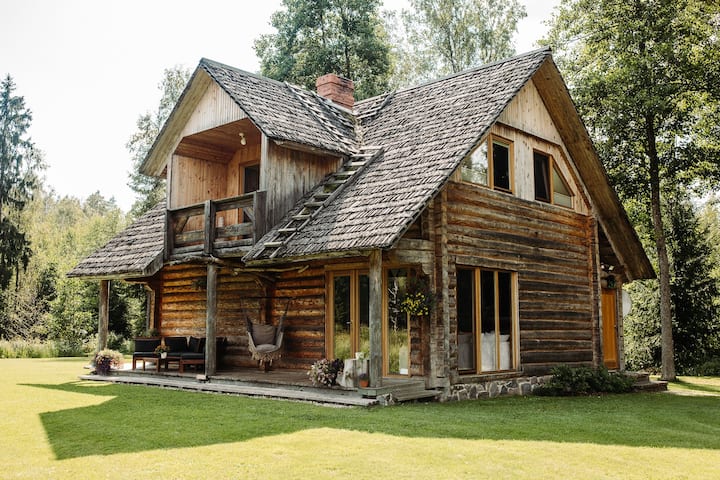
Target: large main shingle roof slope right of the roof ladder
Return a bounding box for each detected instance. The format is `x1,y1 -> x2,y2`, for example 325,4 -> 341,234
245,50 -> 550,260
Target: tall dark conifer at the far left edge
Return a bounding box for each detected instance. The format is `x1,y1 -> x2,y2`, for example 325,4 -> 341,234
0,75 -> 41,292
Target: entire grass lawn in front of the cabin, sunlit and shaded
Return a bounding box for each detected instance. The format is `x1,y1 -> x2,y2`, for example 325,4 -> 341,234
0,359 -> 720,479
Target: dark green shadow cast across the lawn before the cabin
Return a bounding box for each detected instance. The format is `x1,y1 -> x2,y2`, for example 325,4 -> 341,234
28,382 -> 720,460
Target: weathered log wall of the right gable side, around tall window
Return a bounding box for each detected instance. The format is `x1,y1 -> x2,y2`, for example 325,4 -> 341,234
447,182 -> 597,375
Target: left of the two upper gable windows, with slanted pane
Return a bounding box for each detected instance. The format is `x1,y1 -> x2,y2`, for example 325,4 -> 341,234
460,135 -> 513,192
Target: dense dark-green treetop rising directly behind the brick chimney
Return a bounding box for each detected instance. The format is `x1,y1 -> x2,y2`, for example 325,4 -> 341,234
255,0 -> 390,100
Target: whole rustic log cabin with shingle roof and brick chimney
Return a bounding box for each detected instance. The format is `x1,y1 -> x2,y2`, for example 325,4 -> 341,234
69,49 -> 655,399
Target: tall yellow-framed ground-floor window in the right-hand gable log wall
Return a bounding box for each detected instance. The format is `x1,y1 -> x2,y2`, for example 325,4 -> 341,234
457,268 -> 517,373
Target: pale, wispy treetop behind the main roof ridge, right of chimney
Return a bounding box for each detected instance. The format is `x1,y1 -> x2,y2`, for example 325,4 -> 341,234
388,0 -> 527,86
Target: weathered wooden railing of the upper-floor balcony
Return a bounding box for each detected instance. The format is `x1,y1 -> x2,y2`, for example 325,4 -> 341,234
165,191 -> 267,260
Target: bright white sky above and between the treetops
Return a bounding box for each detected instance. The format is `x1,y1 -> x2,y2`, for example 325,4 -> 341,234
0,0 -> 560,211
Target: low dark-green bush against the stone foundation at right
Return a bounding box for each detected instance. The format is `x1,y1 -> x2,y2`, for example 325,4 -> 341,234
535,365 -> 635,397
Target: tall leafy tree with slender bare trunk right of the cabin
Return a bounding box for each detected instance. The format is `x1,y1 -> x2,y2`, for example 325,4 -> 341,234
548,0 -> 720,379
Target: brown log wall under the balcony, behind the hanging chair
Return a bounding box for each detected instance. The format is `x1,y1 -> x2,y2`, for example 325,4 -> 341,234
159,265 -> 325,369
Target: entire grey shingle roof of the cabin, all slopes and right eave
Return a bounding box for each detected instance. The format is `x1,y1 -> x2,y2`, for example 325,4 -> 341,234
70,49 -> 654,278
